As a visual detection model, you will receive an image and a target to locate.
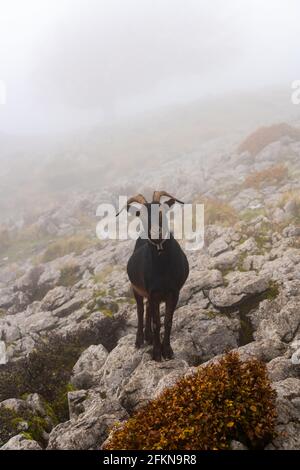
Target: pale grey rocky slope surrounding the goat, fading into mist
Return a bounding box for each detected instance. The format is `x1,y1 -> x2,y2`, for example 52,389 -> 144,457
0,123 -> 300,449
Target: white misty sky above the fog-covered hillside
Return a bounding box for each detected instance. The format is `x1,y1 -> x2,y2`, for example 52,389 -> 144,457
0,0 -> 300,133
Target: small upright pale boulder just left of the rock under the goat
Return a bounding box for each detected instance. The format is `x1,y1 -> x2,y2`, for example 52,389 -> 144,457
71,344 -> 108,389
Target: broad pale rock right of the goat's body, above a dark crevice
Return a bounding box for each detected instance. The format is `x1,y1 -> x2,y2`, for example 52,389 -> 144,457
208,271 -> 268,308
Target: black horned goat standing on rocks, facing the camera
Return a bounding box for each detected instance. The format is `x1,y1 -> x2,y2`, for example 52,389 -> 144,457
117,191 -> 189,361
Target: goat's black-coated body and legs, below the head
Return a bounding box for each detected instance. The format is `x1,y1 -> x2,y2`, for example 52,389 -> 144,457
127,234 -> 189,361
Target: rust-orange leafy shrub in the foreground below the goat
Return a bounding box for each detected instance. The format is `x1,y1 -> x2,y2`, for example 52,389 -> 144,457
104,353 -> 276,450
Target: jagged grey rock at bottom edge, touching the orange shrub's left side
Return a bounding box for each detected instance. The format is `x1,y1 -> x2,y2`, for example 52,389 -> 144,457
47,396 -> 128,450
